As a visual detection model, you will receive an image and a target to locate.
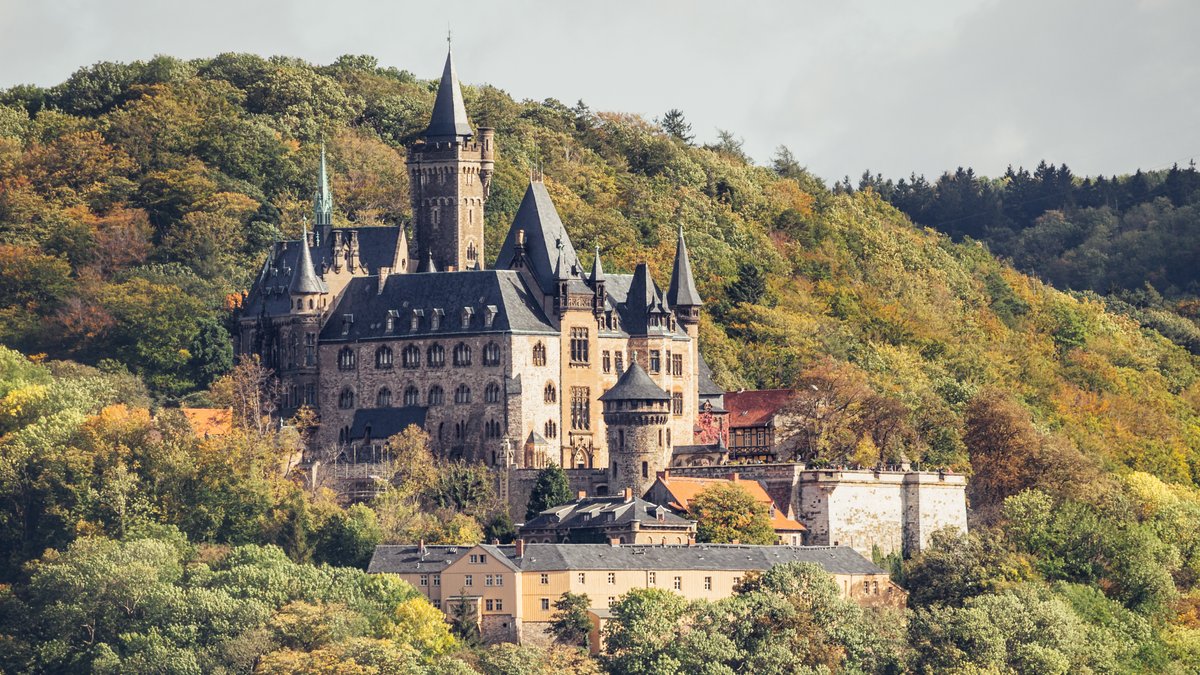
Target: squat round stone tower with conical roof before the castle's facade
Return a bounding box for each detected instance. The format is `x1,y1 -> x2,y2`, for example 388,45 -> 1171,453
600,359 -> 671,496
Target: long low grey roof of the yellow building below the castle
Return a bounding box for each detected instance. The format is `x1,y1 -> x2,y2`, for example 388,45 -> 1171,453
521,544 -> 886,574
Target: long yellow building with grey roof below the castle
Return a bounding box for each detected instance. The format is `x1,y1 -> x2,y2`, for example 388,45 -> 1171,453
367,540 -> 906,644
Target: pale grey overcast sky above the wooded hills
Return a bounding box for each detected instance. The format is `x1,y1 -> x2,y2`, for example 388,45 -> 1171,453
0,0 -> 1200,180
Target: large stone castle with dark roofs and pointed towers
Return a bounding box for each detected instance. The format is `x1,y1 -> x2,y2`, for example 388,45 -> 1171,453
235,48 -> 720,494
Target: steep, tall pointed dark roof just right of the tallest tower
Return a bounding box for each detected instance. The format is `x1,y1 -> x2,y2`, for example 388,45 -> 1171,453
496,183 -> 581,294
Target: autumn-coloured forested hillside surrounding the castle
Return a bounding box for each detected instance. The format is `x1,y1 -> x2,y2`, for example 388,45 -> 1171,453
0,54 -> 1200,673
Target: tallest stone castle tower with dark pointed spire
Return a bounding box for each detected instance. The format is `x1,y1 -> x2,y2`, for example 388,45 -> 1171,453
408,44 -> 496,270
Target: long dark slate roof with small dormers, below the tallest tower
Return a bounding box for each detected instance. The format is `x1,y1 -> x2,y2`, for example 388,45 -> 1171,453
320,269 -> 556,341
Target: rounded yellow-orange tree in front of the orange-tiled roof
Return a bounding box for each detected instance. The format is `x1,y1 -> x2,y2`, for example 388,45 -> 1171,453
688,482 -> 775,545
